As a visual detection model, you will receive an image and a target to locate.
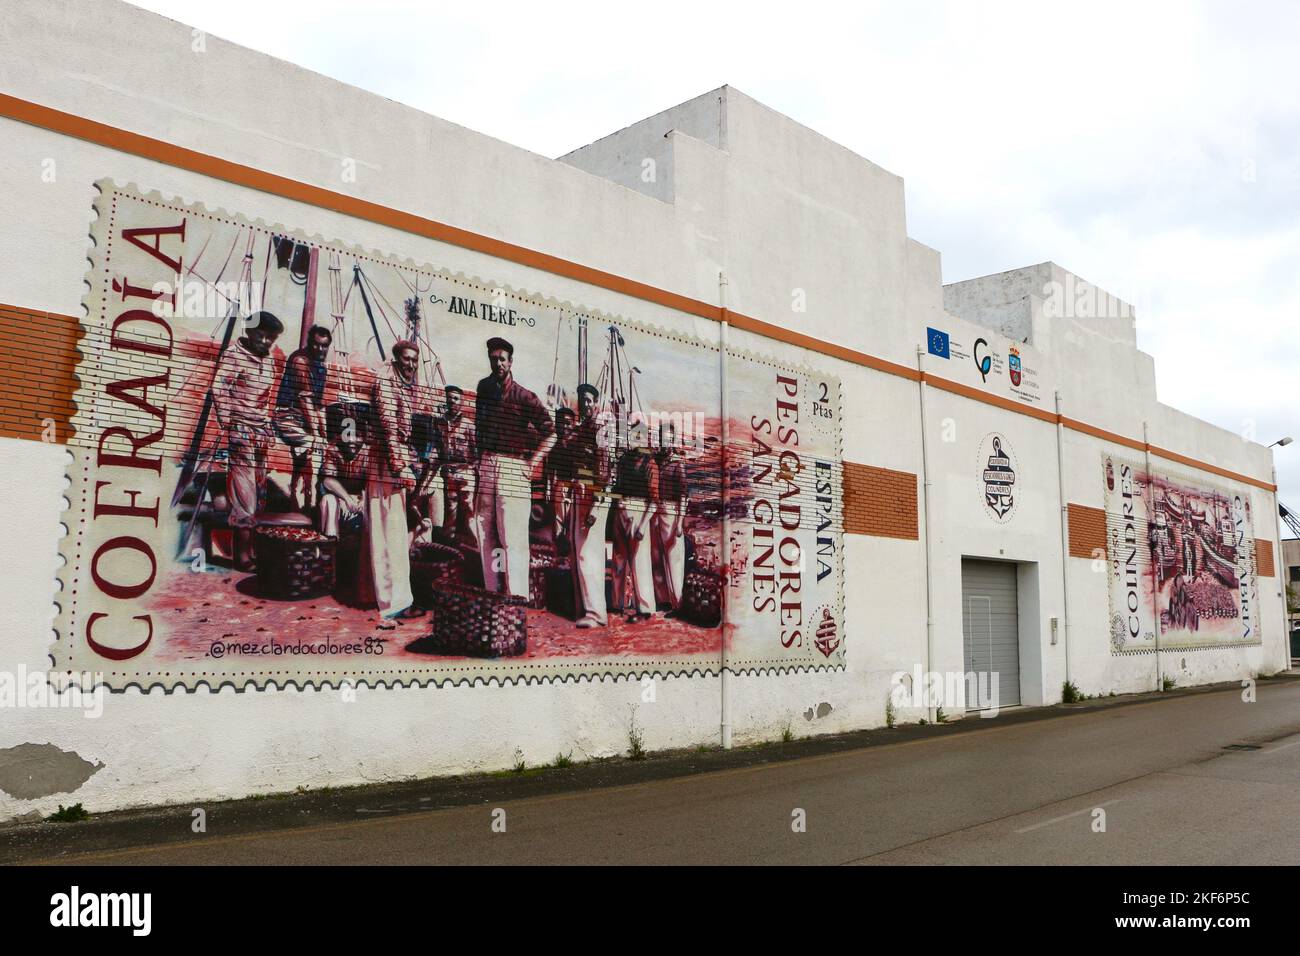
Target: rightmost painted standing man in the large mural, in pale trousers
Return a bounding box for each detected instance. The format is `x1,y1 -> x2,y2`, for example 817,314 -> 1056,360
614,421 -> 659,624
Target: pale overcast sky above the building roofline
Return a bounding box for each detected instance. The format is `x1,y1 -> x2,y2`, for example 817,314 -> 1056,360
137,0 -> 1300,522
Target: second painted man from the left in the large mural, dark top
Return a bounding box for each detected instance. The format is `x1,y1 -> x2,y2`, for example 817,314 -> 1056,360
276,325 -> 334,510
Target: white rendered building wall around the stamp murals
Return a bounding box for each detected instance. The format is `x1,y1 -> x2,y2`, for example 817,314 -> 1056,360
0,0 -> 1282,819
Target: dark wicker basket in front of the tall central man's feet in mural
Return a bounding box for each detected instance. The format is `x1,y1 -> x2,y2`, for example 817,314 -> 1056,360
420,584 -> 528,657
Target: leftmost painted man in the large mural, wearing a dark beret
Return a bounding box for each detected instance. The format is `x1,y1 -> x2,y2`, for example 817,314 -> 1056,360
212,312 -> 285,571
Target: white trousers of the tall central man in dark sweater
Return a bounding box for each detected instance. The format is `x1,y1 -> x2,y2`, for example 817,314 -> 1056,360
473,451 -> 533,600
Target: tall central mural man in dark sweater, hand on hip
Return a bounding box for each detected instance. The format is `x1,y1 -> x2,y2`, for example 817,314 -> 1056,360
475,337 -> 555,600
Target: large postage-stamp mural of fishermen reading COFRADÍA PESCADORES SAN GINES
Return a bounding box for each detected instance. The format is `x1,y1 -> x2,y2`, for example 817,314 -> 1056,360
52,182 -> 845,687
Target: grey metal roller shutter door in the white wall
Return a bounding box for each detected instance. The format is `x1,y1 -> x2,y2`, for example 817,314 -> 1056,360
962,559 -> 1021,708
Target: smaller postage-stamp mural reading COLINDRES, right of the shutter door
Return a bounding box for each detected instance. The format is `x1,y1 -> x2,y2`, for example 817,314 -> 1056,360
1102,455 -> 1260,653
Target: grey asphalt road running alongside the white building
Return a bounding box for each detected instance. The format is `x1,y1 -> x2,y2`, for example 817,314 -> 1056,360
22,682 -> 1300,865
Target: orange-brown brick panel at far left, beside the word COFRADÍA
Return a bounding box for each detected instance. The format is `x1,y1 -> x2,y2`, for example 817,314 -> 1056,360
0,304 -> 82,444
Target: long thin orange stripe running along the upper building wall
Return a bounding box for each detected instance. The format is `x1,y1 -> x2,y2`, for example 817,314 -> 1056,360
0,94 -> 1277,492
